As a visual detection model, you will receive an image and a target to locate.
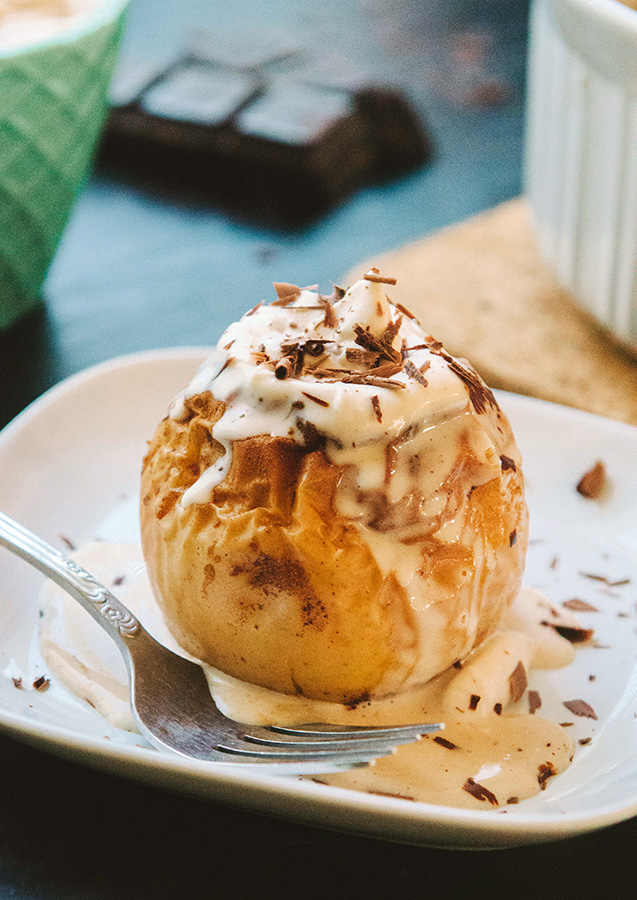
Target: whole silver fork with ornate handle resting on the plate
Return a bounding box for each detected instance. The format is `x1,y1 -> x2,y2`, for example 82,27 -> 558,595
0,513 -> 444,773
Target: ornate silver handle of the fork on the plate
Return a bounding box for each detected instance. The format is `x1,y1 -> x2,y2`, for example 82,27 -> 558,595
0,512 -> 147,663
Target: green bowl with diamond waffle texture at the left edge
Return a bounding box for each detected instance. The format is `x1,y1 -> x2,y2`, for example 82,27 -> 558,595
0,0 -> 127,329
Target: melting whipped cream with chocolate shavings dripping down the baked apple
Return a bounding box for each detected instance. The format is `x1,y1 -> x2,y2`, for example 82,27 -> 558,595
169,270 -> 519,605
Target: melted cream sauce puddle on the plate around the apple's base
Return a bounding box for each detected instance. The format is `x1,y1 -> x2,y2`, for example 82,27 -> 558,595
40,542 -> 578,809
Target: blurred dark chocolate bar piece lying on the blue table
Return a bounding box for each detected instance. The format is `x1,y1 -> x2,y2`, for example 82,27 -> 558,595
99,53 -> 430,227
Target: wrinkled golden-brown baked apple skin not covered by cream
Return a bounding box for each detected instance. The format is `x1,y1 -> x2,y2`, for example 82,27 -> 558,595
141,391 -> 528,704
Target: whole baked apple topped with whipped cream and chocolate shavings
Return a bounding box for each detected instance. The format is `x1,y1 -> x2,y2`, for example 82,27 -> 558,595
141,270 -> 528,705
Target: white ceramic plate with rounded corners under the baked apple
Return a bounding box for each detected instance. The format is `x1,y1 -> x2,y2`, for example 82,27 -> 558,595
0,349 -> 637,848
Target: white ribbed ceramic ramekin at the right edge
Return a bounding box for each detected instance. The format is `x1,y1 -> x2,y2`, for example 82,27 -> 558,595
525,0 -> 637,349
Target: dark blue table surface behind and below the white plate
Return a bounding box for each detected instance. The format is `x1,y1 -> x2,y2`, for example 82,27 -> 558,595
0,0 -> 637,900
